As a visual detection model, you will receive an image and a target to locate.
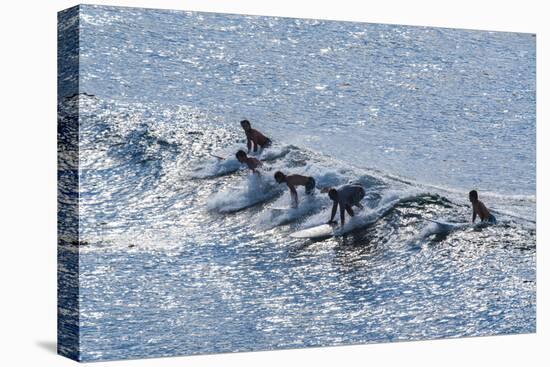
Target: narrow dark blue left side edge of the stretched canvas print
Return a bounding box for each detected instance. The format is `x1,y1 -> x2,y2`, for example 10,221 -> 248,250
57,6 -> 80,360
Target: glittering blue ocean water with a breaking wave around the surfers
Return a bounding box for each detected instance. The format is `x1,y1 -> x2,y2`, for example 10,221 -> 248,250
59,6 -> 536,360
